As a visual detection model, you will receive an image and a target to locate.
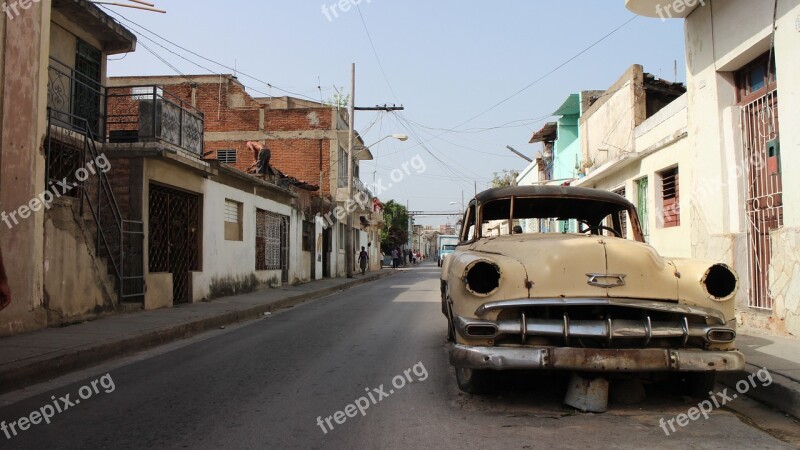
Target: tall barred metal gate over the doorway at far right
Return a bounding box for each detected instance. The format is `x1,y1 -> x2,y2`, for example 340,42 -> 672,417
742,91 -> 783,310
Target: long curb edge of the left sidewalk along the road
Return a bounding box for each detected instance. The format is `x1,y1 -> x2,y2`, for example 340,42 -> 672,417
0,271 -> 396,394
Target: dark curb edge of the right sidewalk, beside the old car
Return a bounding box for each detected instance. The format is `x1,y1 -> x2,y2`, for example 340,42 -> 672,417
717,364 -> 800,419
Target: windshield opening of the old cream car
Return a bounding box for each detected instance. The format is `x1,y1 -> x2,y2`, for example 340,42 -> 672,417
481,197 -> 629,238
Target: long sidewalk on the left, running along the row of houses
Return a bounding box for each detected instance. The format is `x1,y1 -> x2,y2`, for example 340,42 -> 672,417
0,270 -> 395,394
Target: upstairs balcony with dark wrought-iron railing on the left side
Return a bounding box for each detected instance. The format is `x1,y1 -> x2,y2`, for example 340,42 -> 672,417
47,58 -> 204,158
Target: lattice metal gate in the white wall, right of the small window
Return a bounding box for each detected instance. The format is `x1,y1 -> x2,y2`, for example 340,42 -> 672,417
256,209 -> 289,283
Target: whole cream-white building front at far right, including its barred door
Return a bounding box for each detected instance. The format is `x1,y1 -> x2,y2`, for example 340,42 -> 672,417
626,0 -> 800,335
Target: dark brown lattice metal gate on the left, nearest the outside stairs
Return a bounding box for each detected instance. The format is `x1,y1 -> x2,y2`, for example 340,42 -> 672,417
149,183 -> 200,303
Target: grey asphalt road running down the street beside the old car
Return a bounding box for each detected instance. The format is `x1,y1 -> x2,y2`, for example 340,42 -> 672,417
0,264 -> 791,449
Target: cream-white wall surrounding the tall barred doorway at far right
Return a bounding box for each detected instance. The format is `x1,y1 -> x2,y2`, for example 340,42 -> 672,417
685,0 -> 800,334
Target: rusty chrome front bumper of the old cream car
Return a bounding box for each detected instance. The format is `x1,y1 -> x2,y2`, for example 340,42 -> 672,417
450,344 -> 744,372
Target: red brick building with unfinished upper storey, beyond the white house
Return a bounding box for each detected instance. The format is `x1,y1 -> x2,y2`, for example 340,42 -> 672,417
109,75 -> 383,278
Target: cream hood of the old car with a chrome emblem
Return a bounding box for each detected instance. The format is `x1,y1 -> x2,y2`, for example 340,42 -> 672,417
466,234 -> 678,301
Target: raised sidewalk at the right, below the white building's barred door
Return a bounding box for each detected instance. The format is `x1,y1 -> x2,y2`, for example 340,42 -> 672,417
718,332 -> 800,419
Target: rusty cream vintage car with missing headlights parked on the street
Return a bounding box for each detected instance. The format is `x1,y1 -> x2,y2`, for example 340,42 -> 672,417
441,186 -> 744,393
